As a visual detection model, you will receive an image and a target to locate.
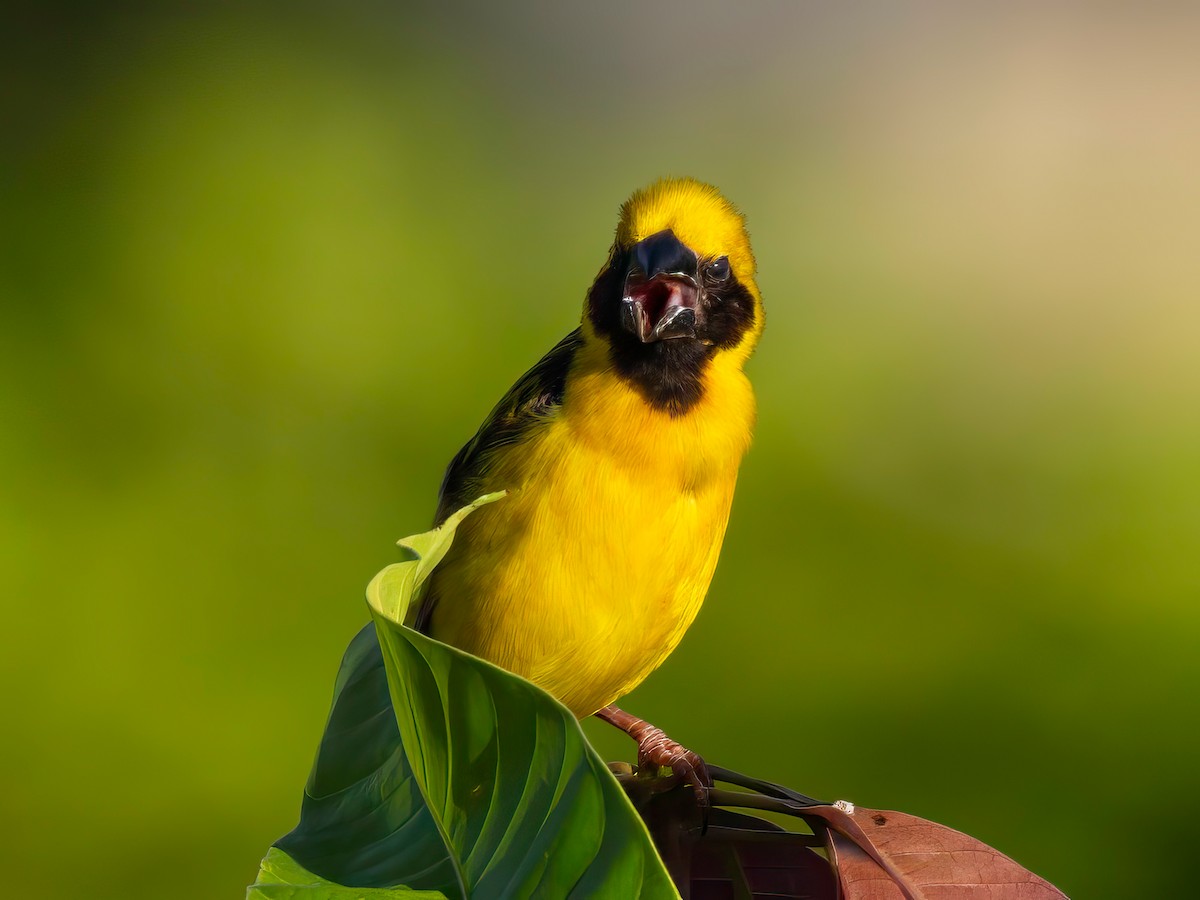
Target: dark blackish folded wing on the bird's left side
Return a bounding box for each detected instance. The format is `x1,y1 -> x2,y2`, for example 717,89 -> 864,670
412,329 -> 583,631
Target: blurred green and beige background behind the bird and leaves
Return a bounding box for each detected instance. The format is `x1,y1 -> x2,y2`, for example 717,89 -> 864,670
0,0 -> 1200,898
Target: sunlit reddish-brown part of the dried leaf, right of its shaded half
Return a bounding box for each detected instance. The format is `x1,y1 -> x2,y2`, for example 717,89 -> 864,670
805,806 -> 1066,900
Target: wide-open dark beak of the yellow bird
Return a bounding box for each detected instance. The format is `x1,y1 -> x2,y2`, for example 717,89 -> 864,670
620,230 -> 701,343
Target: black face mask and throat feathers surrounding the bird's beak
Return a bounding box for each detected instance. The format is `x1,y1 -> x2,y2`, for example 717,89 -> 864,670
588,250 -> 755,416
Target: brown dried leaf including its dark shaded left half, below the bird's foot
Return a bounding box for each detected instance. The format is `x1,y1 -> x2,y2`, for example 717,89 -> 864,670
619,766 -> 1066,900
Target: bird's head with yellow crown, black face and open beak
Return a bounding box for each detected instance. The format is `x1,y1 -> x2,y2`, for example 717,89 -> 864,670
583,179 -> 763,415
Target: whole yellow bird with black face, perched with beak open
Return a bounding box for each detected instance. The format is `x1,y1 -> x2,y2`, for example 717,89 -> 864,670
409,179 -> 763,784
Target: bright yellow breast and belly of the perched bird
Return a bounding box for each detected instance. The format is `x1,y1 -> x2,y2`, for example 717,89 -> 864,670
430,345 -> 754,716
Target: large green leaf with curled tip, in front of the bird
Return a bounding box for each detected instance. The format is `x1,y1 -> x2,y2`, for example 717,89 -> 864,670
266,494 -> 678,899
